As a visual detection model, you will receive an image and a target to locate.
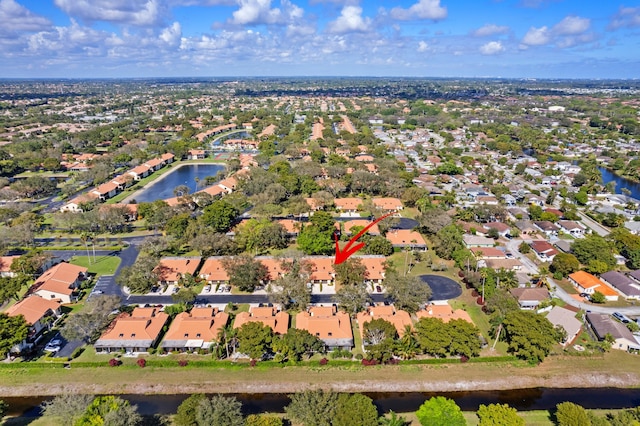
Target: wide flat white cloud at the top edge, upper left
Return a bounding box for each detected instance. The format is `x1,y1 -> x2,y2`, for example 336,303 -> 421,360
54,0 -> 162,26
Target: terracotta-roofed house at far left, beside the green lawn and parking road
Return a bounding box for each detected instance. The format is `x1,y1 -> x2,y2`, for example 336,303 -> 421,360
31,262 -> 87,303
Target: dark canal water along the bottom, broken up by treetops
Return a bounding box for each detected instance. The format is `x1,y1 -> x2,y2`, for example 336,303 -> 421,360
2,388 -> 640,417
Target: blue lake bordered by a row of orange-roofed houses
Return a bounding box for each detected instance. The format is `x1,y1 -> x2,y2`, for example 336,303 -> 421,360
133,164 -> 224,203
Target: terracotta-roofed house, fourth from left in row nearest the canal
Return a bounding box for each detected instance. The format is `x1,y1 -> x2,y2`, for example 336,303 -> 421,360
296,306 -> 353,350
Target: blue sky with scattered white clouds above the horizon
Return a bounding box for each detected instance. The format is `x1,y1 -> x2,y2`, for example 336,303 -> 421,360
0,0 -> 640,78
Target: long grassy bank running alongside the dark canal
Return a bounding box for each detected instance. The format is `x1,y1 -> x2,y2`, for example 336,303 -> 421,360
0,349 -> 640,396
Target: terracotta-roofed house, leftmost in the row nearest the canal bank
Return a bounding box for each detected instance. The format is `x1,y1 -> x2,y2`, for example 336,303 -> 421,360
94,308 -> 169,353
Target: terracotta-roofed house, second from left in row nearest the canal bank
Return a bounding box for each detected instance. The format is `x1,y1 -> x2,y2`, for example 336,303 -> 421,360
160,308 -> 229,352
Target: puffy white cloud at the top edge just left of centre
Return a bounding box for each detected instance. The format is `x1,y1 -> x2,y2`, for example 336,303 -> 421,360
230,0 -> 304,25
